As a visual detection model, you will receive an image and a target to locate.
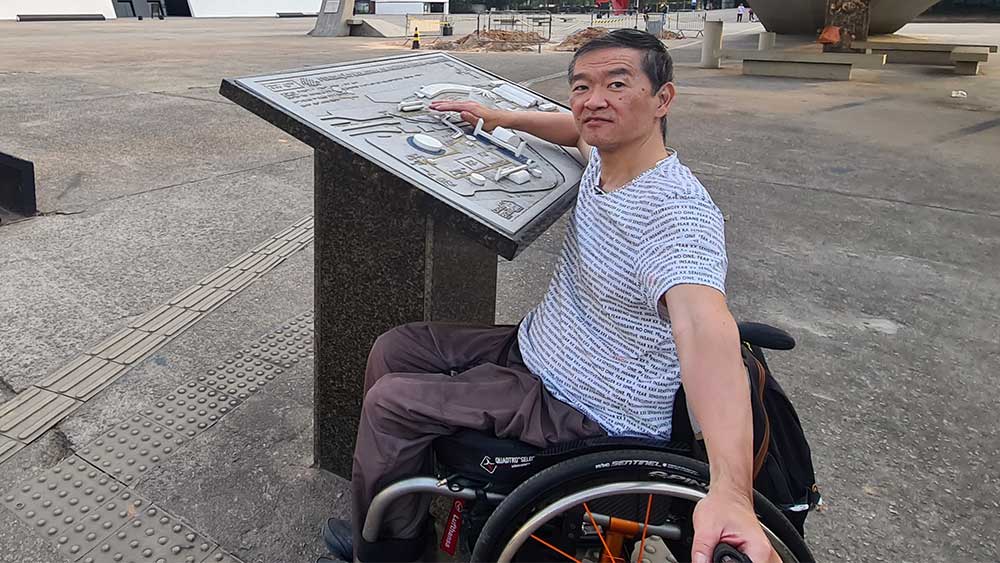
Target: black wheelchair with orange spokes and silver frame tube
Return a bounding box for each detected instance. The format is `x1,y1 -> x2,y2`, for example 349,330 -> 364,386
362,323 -> 814,563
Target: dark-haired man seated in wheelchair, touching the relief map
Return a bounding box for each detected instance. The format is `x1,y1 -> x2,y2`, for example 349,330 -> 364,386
324,30 -> 777,563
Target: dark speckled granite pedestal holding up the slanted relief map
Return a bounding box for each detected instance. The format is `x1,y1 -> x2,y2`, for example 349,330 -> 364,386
314,148 -> 497,479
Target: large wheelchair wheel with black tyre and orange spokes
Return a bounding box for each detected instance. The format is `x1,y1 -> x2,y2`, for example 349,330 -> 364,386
472,450 -> 813,563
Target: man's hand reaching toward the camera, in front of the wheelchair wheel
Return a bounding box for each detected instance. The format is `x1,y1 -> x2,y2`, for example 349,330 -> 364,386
691,489 -> 781,563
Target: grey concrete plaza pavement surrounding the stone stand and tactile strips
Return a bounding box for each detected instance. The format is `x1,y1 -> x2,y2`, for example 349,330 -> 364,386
0,19 -> 1000,562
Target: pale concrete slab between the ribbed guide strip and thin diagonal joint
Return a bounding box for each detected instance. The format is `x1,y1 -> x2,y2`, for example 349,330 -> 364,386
0,157 -> 312,390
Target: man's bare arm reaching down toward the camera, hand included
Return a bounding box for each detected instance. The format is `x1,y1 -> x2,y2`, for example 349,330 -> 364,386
663,284 -> 780,563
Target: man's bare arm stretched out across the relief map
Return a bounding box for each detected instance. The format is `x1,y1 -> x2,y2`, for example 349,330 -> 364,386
431,100 -> 590,160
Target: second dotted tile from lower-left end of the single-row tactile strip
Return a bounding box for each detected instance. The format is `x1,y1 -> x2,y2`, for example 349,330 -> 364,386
140,382 -> 242,438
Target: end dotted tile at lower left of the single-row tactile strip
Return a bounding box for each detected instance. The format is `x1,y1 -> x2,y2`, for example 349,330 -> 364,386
77,415 -> 186,486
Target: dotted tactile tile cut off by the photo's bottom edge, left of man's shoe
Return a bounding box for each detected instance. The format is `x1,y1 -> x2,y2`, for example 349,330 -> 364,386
81,505 -> 219,563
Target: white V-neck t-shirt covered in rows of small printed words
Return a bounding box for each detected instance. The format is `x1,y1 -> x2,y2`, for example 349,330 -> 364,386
518,149 -> 727,438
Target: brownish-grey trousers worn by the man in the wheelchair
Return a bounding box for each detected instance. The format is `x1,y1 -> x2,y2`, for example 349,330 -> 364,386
351,323 -> 604,549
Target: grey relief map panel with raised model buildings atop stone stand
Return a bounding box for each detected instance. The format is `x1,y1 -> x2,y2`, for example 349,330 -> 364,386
238,53 -> 581,234
